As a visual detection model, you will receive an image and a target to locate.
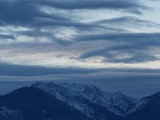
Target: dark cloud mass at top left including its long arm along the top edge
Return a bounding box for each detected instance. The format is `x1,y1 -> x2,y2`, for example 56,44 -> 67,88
0,0 -> 143,26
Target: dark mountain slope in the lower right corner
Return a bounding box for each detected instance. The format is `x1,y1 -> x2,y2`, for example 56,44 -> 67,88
125,92 -> 160,120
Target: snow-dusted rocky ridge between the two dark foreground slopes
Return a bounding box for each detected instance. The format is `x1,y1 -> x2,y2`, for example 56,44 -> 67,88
33,82 -> 138,117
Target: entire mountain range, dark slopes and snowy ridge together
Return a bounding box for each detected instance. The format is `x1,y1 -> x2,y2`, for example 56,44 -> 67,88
0,82 -> 160,120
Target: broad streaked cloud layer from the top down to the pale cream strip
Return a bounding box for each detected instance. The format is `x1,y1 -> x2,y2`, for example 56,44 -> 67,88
0,0 -> 160,68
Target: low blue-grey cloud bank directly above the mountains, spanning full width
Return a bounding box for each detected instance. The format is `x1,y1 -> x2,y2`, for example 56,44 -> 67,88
0,64 -> 160,97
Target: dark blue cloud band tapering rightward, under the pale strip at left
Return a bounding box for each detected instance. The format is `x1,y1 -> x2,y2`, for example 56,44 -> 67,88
0,63 -> 107,76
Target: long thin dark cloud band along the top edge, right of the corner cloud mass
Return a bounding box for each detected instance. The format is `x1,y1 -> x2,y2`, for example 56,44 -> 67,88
37,0 -> 144,9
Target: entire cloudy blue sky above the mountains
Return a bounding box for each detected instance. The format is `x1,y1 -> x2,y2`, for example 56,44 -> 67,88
0,0 -> 160,97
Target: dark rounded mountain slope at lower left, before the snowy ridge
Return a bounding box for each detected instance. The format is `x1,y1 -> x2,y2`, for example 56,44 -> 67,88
0,87 -> 90,120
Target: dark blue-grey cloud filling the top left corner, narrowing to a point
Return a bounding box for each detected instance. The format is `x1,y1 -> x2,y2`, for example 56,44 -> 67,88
0,0 -> 69,26
